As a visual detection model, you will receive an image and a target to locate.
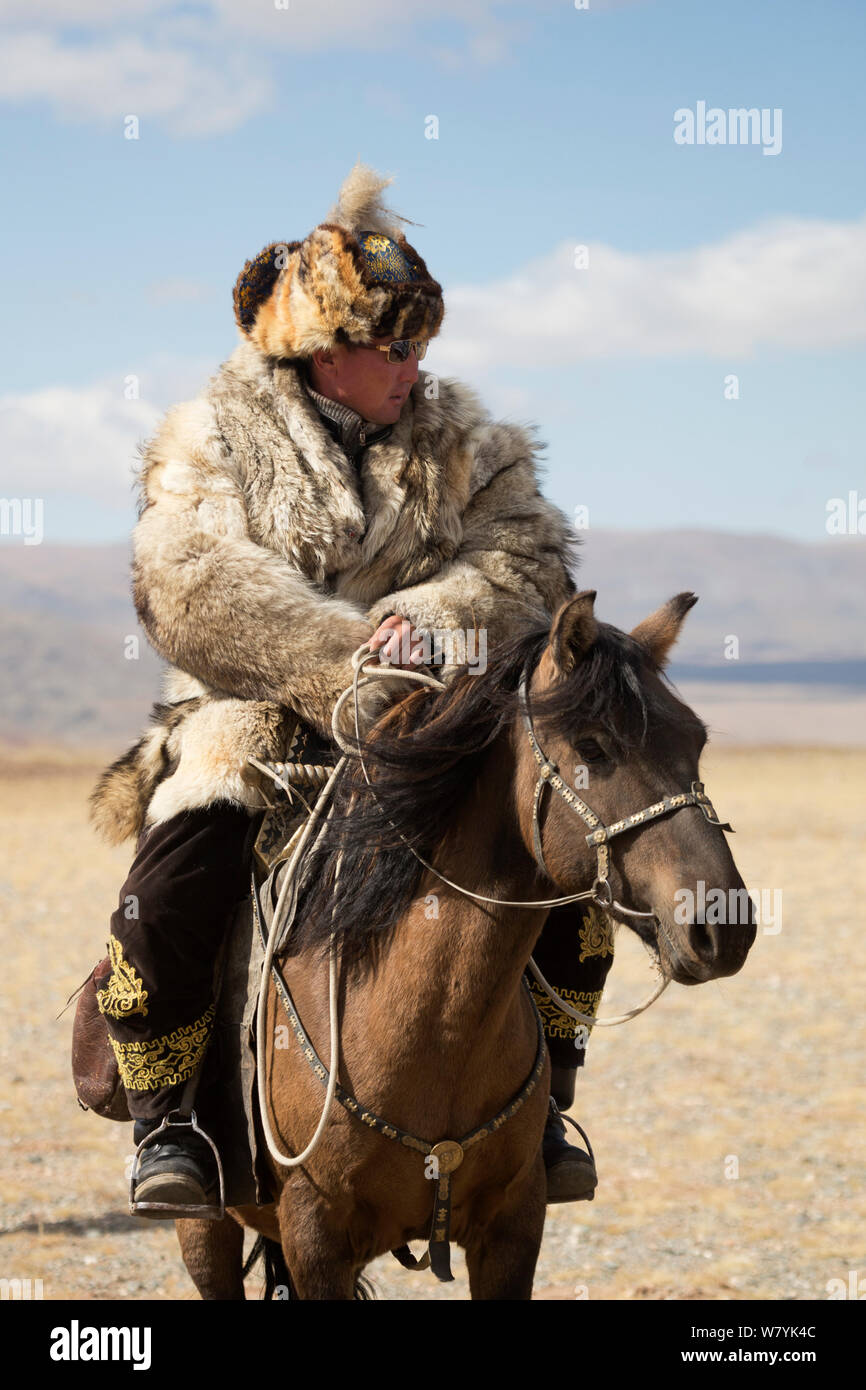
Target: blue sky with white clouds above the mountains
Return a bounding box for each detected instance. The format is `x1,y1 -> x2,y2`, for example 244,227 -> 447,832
0,0 -> 866,543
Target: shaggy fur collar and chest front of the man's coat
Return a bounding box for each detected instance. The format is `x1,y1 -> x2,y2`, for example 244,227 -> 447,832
210,342 -> 469,598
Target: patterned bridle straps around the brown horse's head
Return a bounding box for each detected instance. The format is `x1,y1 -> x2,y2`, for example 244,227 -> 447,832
518,669 -> 734,917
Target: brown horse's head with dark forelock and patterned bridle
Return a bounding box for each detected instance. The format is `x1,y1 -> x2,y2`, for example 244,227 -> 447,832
514,591 -> 755,984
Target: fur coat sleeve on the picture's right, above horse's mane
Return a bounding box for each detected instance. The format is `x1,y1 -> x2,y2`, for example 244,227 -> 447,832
368,423 -> 580,663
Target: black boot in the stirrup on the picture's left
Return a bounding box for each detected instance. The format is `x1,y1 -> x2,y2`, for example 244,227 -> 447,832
132,1119 -> 220,1220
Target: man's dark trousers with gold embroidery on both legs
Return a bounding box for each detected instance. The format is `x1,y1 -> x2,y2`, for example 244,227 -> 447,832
96,802 -> 613,1120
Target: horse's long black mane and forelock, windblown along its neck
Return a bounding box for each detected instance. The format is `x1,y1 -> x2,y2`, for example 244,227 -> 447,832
291,623 -> 703,960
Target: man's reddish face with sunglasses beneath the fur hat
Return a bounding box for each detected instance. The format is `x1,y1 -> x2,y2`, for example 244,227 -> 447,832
310,338 -> 418,425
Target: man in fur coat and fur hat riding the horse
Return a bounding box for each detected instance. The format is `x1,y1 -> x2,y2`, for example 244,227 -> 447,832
92,163 -> 612,1213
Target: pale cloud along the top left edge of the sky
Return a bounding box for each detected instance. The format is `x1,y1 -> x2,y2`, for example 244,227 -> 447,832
0,0 -> 542,136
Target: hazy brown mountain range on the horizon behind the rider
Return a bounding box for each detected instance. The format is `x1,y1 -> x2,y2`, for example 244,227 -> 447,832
0,531 -> 866,752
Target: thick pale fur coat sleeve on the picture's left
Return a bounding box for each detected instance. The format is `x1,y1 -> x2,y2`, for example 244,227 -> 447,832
132,399 -> 383,734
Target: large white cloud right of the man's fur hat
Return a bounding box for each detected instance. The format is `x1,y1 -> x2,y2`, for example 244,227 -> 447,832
442,218 -> 866,368
